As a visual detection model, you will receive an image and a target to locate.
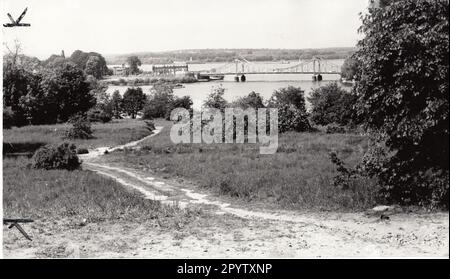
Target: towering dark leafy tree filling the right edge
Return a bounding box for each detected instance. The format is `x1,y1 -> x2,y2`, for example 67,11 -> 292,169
354,0 -> 449,206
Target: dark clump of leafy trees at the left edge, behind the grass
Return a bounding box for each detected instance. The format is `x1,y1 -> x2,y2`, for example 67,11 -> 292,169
3,63 -> 95,126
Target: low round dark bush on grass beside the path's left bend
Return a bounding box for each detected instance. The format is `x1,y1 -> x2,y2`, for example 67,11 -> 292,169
32,142 -> 81,170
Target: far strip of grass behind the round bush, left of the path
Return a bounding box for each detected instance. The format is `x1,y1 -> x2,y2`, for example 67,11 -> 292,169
3,119 -> 150,153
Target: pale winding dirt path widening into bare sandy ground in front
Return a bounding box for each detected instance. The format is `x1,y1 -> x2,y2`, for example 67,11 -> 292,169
4,127 -> 449,258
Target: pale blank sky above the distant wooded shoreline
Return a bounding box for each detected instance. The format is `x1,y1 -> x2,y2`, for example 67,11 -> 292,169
0,0 -> 368,59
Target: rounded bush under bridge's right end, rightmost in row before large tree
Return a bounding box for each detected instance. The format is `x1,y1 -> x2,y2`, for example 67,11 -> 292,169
308,82 -> 357,126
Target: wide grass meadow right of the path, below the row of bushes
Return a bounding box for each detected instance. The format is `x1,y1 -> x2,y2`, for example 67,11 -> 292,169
105,122 -> 376,211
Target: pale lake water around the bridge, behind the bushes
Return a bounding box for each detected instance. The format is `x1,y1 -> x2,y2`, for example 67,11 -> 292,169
107,60 -> 343,109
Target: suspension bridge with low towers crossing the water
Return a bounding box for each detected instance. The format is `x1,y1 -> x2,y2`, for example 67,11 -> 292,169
196,57 -> 341,81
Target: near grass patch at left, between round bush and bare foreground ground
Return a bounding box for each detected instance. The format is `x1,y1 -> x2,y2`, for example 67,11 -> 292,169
3,158 -> 186,222
